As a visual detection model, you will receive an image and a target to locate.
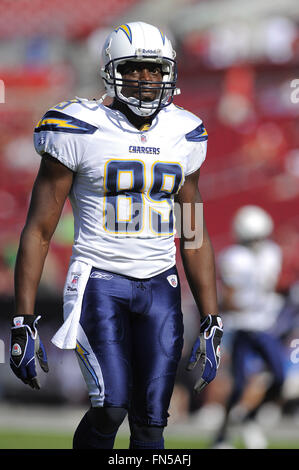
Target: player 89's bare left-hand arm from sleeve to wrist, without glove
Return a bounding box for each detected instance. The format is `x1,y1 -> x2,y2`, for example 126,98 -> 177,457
15,156 -> 73,315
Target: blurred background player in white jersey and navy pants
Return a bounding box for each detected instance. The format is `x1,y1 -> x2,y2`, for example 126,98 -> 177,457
216,205 -> 284,448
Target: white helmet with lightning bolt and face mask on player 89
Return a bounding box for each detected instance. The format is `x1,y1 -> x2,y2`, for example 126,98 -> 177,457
101,22 -> 179,116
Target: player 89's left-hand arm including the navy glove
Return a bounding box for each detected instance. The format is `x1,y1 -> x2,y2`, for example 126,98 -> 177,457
10,156 -> 73,390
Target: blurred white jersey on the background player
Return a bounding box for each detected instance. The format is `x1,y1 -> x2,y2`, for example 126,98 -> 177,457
218,240 -> 283,330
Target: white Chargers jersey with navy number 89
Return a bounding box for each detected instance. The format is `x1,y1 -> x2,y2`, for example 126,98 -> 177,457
34,99 -> 207,278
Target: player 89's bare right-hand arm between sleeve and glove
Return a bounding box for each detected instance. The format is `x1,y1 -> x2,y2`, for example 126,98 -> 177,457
177,170 -> 218,317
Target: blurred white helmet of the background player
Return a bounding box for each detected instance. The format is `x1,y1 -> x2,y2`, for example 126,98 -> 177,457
233,205 -> 273,243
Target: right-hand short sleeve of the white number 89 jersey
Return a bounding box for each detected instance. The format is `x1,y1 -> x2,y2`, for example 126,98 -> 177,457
185,123 -> 208,176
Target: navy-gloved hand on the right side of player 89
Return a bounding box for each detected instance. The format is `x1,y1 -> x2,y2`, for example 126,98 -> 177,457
186,315 -> 223,393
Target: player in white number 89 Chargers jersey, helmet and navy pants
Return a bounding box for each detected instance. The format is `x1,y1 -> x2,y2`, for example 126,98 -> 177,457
11,22 -> 222,449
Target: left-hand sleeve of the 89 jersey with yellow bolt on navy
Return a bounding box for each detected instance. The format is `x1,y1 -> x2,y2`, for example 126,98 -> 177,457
34,110 -> 97,171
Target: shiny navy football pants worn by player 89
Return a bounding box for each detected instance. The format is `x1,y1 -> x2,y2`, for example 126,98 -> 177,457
76,267 -> 183,426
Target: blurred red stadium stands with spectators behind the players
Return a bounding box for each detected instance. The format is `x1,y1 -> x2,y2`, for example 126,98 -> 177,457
0,0 -> 299,444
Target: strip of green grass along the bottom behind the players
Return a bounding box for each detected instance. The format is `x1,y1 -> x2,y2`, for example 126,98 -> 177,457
0,430 -> 299,449
